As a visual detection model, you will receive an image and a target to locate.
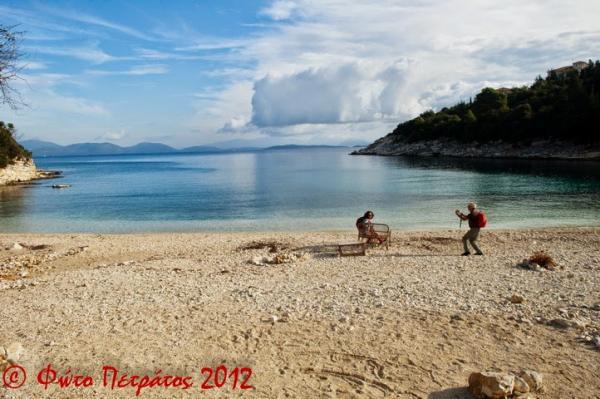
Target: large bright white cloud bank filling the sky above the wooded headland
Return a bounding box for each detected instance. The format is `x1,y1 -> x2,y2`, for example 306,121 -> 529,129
210,0 -> 600,139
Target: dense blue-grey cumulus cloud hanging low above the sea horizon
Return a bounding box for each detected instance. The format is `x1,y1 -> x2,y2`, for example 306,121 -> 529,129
252,62 -> 423,127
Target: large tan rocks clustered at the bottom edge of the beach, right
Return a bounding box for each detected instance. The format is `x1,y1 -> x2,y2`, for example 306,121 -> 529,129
469,370 -> 543,399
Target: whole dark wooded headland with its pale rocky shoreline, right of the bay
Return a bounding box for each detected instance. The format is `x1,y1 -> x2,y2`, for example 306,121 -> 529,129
352,61 -> 600,159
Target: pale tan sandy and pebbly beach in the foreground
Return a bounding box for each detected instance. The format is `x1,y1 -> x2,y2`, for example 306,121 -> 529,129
0,228 -> 600,398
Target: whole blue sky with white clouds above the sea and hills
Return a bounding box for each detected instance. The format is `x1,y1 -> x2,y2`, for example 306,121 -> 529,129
0,0 -> 600,148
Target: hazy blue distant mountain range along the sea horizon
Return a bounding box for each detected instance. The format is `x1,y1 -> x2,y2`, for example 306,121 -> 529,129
22,140 -> 352,157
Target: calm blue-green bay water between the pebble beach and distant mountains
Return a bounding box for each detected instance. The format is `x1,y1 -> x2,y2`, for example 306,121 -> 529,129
0,148 -> 600,232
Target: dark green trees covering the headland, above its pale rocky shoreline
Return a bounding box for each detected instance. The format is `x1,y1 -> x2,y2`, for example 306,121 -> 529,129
390,61 -> 600,143
